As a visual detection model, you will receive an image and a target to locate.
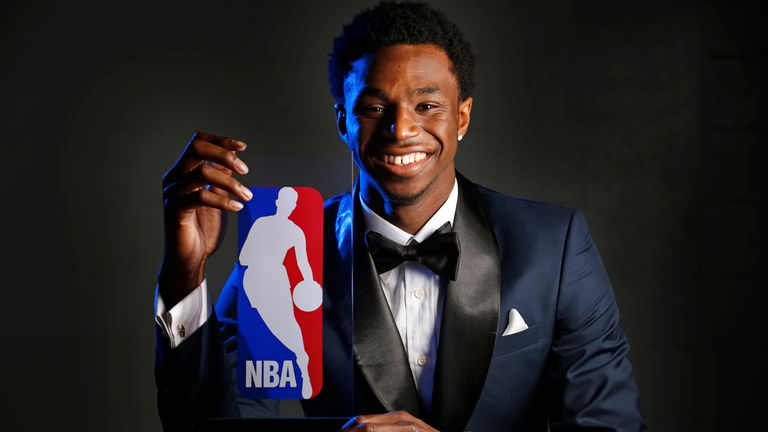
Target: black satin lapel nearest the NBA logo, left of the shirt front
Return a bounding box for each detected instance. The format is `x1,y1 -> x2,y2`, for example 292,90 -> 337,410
352,181 -> 420,417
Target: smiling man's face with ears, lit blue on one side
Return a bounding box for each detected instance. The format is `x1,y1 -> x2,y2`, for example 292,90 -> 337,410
338,44 -> 472,204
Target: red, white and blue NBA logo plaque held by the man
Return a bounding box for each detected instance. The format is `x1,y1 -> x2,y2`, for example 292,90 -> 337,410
237,187 -> 323,399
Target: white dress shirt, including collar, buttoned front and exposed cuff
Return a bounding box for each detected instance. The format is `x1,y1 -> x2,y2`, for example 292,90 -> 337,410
155,182 -> 459,409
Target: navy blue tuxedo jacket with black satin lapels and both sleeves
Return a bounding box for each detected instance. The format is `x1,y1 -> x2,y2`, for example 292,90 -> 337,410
156,175 -> 646,431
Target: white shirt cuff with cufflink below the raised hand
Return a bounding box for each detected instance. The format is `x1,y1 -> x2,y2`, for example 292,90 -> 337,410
155,279 -> 212,348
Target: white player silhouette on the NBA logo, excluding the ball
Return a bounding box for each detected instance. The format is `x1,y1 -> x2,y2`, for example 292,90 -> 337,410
240,187 -> 322,399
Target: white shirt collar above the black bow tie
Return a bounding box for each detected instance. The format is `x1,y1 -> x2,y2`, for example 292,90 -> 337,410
360,180 -> 459,245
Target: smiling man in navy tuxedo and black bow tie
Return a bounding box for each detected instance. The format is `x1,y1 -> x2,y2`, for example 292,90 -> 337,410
157,3 -> 645,431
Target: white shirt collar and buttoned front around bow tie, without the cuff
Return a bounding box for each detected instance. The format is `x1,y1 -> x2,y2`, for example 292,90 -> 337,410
360,182 -> 459,410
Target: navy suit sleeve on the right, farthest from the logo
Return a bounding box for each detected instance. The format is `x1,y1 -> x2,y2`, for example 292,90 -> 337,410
547,212 -> 647,432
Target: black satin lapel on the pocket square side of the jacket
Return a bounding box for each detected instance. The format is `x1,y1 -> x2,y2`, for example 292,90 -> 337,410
431,173 -> 501,430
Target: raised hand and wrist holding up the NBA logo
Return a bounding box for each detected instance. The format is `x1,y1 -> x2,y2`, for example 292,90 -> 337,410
158,132 -> 253,308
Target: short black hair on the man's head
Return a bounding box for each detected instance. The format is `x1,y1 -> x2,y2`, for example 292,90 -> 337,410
328,1 -> 475,103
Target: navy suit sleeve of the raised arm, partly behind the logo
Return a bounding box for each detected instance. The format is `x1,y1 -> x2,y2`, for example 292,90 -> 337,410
155,266 -> 277,431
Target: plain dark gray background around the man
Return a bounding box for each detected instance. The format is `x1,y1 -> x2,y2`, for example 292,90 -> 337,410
0,0 -> 768,431
